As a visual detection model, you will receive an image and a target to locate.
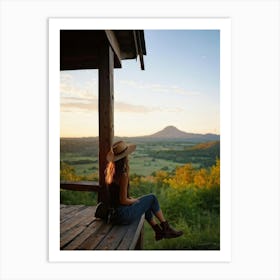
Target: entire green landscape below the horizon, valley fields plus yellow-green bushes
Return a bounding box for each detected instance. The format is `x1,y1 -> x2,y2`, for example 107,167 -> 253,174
60,138 -> 220,250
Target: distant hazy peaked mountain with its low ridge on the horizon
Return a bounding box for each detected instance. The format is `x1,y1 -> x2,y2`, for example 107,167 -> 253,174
143,126 -> 220,141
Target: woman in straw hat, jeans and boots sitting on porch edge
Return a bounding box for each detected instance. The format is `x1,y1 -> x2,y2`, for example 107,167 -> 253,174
105,141 -> 183,240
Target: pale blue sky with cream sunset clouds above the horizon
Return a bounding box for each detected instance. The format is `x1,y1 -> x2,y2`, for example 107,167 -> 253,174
60,30 -> 220,137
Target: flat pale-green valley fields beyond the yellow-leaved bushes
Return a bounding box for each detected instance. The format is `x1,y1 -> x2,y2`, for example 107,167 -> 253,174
60,138 -> 220,176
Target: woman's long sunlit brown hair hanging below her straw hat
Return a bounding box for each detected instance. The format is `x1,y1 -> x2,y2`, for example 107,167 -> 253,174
105,157 -> 129,185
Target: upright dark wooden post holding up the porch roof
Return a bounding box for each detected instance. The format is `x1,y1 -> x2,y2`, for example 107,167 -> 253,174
98,44 -> 114,202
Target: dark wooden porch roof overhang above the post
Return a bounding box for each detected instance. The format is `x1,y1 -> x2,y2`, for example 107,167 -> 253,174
60,30 -> 146,70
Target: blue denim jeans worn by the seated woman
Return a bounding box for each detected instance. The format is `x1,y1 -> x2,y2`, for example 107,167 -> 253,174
115,194 -> 160,224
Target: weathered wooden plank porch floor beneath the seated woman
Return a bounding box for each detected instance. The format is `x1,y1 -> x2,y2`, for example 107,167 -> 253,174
60,205 -> 144,250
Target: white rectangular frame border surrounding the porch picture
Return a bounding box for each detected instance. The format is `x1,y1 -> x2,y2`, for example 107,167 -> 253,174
49,18 -> 231,262
